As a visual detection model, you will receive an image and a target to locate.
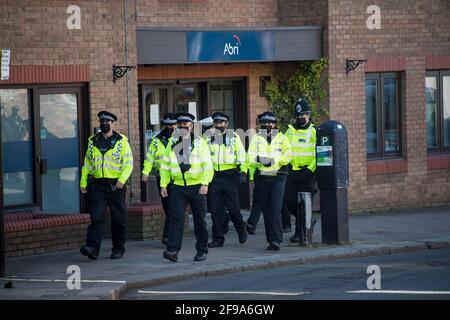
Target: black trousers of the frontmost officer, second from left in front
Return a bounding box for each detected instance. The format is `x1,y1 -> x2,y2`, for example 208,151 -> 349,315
167,185 -> 208,253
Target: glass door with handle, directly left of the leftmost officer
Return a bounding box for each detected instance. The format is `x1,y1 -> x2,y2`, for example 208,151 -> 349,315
35,88 -> 81,213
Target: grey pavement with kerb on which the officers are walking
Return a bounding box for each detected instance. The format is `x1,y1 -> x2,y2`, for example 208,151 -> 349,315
0,206 -> 450,300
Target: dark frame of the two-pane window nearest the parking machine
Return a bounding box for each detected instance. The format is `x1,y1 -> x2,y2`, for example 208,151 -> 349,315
364,72 -> 403,160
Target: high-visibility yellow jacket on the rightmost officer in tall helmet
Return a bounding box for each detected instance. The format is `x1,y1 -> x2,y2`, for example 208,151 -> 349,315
286,124 -> 317,172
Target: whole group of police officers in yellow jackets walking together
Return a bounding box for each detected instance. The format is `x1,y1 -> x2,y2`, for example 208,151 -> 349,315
80,98 -> 316,262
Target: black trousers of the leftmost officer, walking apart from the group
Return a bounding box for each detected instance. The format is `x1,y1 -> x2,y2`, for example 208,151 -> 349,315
86,182 -> 127,254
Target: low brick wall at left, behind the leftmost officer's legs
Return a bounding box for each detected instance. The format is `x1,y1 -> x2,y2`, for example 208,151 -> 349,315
5,203 -> 184,257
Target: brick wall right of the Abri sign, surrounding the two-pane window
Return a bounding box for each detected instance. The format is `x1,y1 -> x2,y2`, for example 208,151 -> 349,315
328,0 -> 450,210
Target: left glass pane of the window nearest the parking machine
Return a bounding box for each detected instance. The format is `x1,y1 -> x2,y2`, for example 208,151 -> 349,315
366,79 -> 378,153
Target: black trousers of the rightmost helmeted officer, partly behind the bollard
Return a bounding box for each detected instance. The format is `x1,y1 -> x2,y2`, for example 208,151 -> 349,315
284,171 -> 315,227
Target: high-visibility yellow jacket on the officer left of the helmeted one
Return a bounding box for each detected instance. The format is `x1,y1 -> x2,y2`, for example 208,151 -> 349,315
247,132 -> 292,181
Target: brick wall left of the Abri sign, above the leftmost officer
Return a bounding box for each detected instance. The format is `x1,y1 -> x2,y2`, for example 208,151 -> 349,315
0,0 -> 140,201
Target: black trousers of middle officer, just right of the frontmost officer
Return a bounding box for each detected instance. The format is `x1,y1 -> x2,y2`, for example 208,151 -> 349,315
208,170 -> 245,243
